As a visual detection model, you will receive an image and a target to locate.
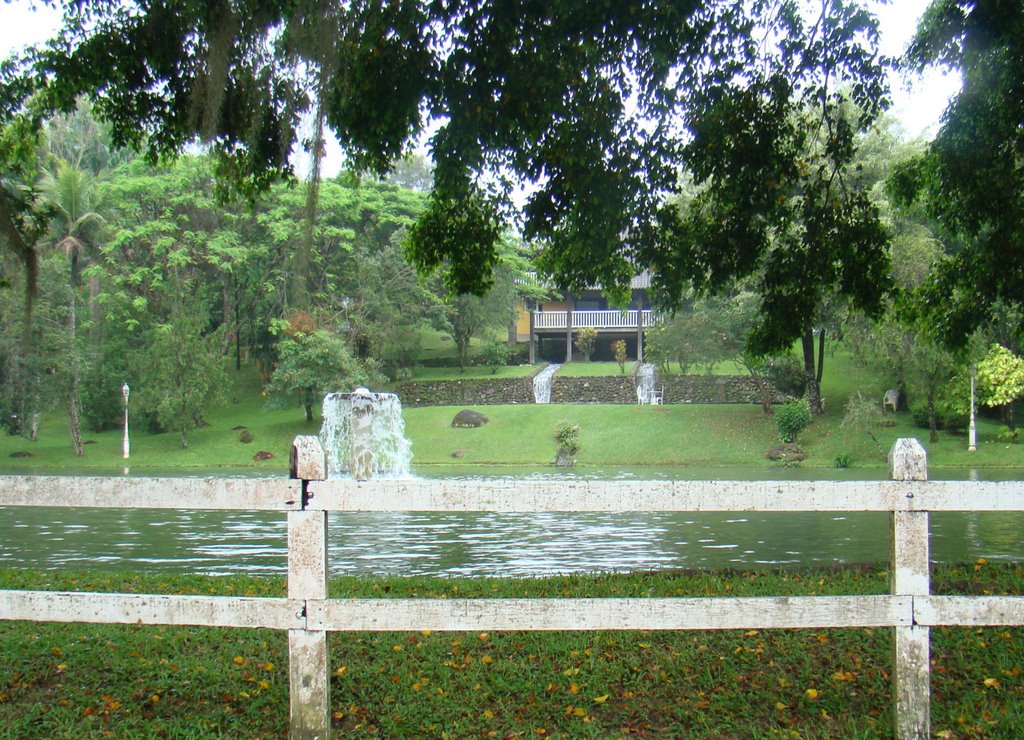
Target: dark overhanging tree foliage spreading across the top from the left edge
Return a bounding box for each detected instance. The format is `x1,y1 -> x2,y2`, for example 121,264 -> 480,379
0,0 -> 884,323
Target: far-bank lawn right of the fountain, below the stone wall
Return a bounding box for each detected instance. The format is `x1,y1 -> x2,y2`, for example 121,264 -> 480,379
404,404 -> 1011,468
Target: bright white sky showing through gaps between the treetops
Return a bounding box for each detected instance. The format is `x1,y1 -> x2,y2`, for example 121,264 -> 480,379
0,0 -> 961,162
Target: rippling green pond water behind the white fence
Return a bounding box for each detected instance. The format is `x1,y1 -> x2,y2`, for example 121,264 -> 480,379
0,469 -> 1024,576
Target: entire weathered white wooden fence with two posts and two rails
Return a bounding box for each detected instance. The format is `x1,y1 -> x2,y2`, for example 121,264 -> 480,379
0,437 -> 1024,738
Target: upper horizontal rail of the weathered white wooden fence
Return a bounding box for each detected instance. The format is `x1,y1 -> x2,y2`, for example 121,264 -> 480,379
0,476 -> 1024,514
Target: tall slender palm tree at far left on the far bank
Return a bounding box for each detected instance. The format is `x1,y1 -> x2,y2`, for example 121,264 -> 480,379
39,160 -> 103,456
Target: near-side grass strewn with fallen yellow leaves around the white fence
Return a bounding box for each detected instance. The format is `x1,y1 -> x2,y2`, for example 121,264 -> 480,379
0,564 -> 1024,738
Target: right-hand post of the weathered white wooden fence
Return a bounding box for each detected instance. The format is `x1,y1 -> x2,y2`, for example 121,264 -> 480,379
889,437 -> 931,739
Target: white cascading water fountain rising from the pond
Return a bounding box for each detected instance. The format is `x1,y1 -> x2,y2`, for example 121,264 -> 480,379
319,388 -> 413,480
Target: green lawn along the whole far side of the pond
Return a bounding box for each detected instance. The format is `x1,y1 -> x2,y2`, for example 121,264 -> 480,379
0,353 -> 1024,475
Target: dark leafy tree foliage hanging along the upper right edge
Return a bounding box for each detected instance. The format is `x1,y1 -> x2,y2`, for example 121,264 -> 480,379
893,0 -> 1024,347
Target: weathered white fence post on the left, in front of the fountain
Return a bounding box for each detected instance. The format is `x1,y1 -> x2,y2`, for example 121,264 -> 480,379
288,435 -> 331,740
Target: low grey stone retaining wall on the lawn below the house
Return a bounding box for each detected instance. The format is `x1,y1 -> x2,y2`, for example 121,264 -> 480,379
395,367 -> 792,407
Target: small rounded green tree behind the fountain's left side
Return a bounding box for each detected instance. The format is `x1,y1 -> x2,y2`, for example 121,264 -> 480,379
266,331 -> 372,422
